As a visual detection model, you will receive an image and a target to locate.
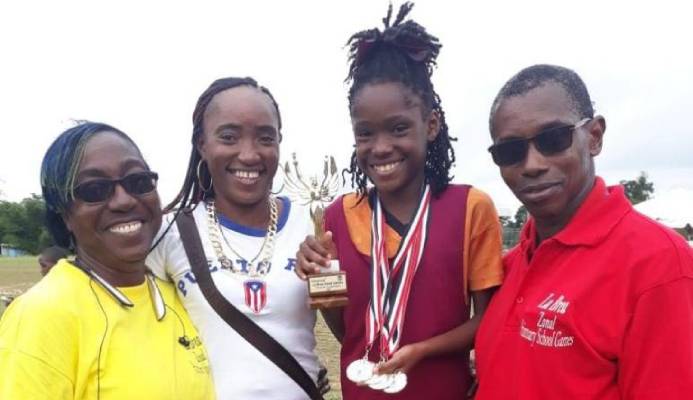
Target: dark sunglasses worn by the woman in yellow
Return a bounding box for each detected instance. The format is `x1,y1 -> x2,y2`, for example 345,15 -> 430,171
73,171 -> 159,203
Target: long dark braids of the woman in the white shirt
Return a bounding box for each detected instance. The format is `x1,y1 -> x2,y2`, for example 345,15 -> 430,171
164,77 -> 282,212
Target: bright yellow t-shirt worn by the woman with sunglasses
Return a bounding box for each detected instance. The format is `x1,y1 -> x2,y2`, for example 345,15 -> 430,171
0,260 -> 214,400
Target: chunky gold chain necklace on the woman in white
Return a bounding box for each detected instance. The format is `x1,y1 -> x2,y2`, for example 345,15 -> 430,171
205,196 -> 279,277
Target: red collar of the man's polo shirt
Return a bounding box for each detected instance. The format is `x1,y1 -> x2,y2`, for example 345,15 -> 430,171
521,177 -> 633,251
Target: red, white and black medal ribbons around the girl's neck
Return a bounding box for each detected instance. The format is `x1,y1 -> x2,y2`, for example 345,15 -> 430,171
366,185 -> 431,359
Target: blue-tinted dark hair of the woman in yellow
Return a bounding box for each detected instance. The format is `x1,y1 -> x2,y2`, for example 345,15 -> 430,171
41,121 -> 146,250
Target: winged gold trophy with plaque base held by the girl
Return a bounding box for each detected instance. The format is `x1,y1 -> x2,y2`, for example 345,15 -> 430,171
284,153 -> 349,309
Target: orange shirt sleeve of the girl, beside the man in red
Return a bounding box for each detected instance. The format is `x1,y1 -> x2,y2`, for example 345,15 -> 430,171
462,188 -> 503,298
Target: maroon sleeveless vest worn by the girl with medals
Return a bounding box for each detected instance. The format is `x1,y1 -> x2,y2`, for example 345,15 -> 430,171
325,185 -> 470,400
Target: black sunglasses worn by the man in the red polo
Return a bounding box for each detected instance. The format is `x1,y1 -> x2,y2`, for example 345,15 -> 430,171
488,118 -> 592,167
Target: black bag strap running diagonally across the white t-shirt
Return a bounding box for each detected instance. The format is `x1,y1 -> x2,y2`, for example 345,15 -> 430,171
176,210 -> 323,400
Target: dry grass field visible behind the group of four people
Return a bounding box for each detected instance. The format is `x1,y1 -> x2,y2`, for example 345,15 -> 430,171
0,256 -> 342,400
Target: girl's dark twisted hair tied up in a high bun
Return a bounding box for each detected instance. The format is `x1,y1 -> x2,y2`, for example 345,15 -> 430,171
343,2 -> 456,197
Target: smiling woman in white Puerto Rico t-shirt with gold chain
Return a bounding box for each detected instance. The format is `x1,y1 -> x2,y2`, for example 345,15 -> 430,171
147,78 -> 326,400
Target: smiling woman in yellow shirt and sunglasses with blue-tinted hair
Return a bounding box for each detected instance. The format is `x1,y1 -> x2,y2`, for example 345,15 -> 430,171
0,122 -> 214,400
